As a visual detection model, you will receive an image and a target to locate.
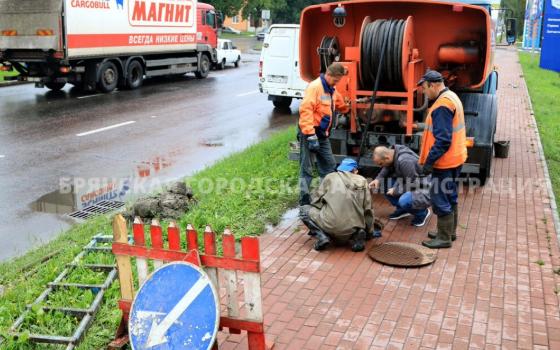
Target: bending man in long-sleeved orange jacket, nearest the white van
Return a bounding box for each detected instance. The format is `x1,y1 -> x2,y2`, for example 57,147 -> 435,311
298,63 -> 349,206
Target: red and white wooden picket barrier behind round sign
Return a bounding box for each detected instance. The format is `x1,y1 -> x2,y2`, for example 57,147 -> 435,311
110,215 -> 272,350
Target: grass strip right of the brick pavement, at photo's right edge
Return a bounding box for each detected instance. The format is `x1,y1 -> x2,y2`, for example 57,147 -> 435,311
519,52 -> 560,217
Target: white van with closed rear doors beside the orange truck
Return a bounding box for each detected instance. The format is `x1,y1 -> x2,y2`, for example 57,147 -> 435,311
259,24 -> 307,108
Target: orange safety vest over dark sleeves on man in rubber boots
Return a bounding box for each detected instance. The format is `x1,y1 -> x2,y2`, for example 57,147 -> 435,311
418,90 -> 467,169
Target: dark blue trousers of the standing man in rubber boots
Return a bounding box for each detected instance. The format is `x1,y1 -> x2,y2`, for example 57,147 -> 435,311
430,167 -> 461,216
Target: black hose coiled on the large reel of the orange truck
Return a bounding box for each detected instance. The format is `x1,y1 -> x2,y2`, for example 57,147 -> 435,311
360,19 -> 406,91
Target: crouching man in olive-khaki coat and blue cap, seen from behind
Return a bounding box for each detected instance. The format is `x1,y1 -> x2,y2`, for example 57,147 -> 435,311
301,158 -> 374,252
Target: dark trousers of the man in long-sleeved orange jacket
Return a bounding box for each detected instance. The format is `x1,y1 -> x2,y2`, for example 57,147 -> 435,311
298,132 -> 336,205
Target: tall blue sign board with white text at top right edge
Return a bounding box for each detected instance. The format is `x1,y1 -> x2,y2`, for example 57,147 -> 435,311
540,0 -> 560,72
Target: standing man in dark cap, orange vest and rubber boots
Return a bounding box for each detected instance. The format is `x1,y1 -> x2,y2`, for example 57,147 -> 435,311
418,70 -> 467,249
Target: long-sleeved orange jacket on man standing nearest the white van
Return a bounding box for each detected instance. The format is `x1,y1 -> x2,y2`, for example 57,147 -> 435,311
299,77 -> 349,136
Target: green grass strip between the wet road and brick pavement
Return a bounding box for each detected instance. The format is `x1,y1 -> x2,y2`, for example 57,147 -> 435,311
0,128 -> 298,350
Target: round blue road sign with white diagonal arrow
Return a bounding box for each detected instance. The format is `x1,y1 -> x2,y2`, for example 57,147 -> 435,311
128,262 -> 220,350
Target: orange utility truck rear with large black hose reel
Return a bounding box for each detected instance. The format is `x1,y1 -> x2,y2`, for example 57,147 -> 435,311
291,0 -> 516,184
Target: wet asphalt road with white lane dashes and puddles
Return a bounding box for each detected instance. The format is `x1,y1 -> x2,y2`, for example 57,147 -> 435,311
0,54 -> 299,261
